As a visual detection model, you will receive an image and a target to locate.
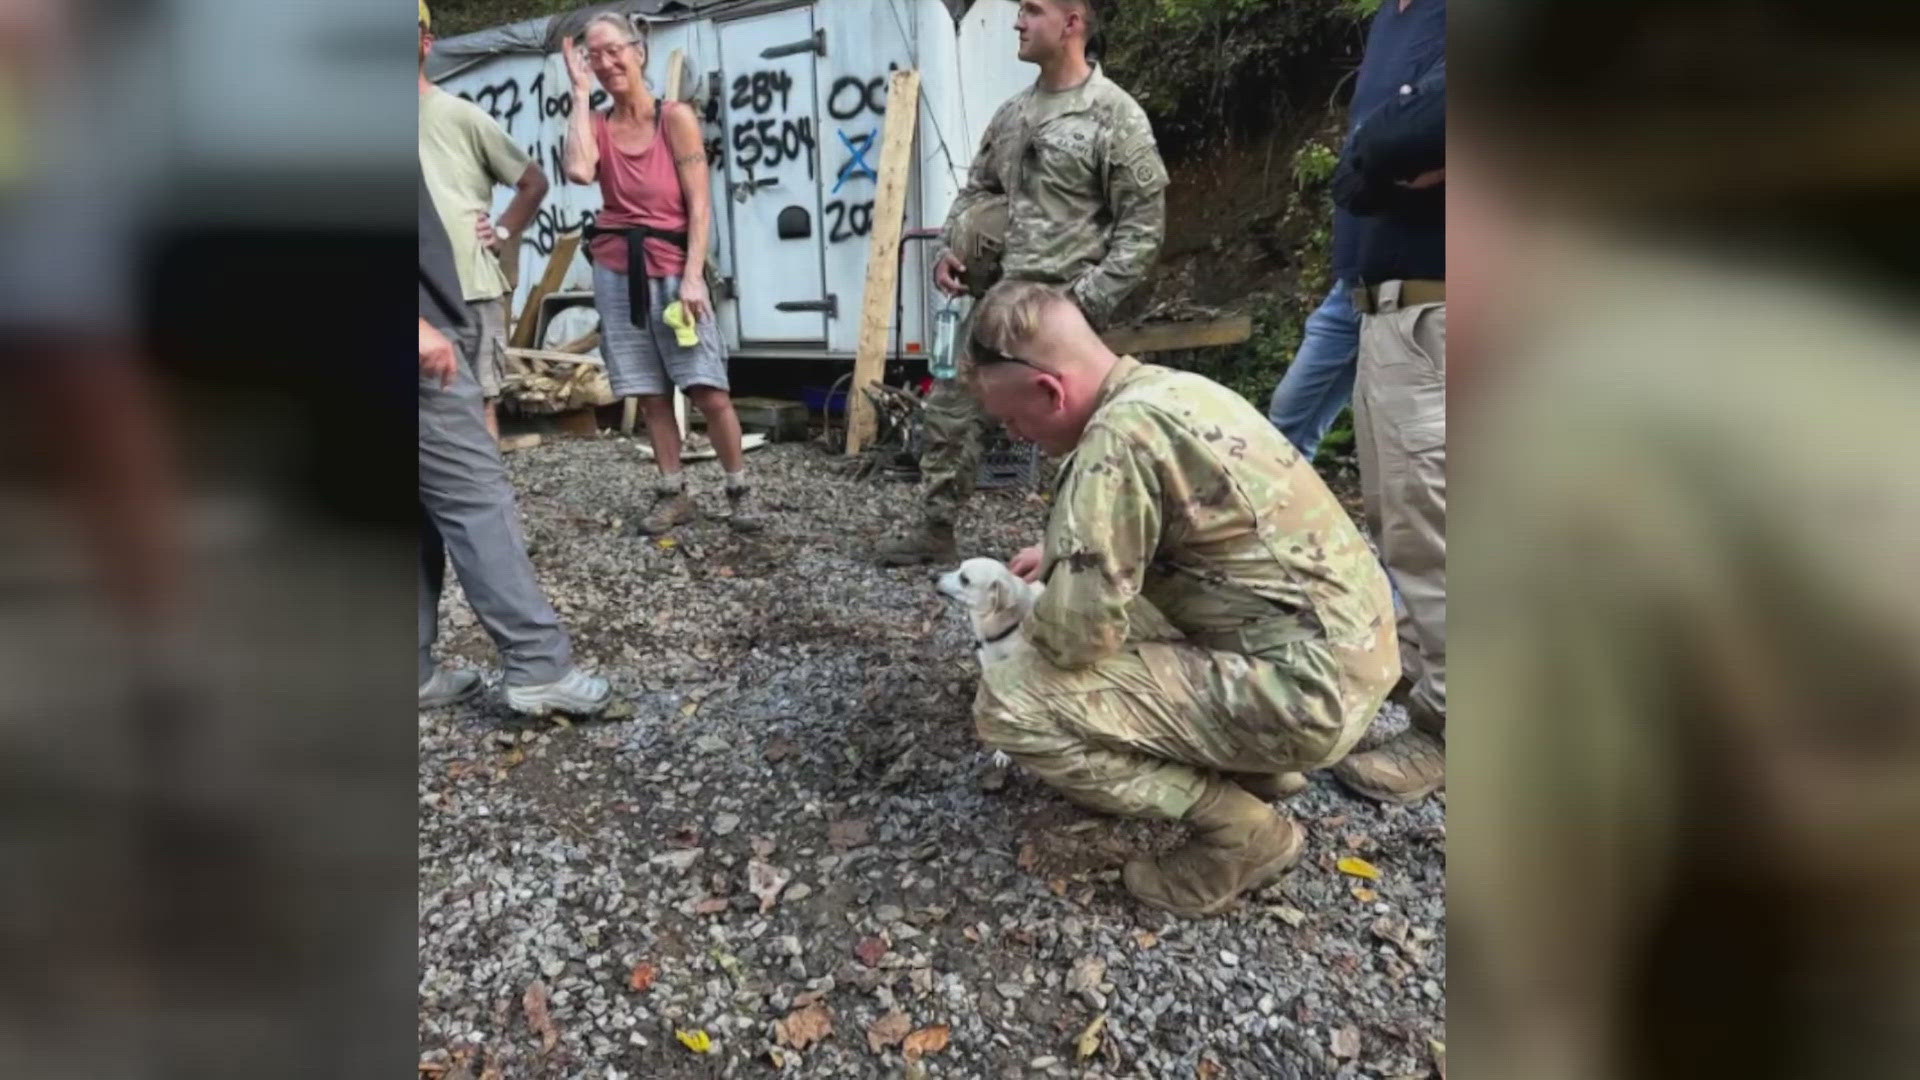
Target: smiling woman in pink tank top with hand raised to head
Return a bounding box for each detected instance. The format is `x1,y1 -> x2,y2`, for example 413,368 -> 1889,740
563,13 -> 758,536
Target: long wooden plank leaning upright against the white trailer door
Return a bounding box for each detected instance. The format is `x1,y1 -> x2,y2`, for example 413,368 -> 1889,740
847,69 -> 920,454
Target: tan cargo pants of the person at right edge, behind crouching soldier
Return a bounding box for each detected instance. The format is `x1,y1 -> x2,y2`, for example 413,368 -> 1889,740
1354,281 -> 1446,734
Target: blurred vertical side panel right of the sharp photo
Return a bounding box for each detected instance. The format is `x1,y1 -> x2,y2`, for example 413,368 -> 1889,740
1448,0 -> 1920,1080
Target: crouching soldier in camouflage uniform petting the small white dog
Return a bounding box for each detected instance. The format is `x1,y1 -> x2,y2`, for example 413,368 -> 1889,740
968,281 -> 1400,917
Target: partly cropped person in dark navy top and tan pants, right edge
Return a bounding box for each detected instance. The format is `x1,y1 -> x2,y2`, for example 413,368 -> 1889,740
1332,63 -> 1446,803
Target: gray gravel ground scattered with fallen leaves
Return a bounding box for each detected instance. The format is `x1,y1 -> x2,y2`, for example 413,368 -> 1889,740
420,438 -> 1446,1080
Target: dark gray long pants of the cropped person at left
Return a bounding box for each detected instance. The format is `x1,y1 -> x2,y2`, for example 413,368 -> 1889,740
420,357 -> 572,686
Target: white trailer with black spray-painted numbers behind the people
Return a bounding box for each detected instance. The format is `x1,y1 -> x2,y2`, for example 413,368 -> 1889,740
428,0 -> 1037,359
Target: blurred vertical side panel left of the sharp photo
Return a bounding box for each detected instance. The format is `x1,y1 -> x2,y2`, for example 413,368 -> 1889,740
0,0 -> 417,1076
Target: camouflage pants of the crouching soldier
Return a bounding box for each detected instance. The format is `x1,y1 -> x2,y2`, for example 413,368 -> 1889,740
973,632 -> 1400,821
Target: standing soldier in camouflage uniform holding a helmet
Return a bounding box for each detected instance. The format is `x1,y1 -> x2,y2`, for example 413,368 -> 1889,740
879,0 -> 1167,565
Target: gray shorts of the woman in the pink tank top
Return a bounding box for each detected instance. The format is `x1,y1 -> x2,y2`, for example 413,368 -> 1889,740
593,263 -> 728,398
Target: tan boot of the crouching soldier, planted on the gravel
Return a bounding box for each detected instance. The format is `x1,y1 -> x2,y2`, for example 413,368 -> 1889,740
1121,780 -> 1308,919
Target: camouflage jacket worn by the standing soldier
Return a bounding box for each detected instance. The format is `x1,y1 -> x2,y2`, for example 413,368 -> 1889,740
947,65 -> 1167,323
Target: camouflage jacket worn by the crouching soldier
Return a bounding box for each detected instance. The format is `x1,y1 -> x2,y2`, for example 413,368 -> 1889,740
1027,357 -> 1394,669
